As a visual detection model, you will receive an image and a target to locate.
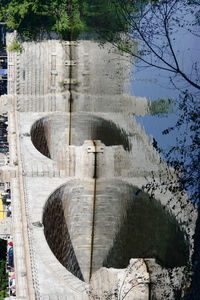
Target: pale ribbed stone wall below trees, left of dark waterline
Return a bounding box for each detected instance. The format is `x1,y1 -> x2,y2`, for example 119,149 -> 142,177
14,41 -> 68,112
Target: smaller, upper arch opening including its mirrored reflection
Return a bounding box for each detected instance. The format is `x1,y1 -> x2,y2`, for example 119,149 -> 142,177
31,114 -> 130,160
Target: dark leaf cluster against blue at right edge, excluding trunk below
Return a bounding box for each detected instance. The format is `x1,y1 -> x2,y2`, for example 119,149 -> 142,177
161,91 -> 200,204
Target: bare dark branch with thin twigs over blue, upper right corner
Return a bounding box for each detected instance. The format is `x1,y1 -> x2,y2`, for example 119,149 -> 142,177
108,0 -> 200,89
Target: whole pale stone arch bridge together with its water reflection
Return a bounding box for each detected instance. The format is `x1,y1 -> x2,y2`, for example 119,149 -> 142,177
0,34 -> 196,300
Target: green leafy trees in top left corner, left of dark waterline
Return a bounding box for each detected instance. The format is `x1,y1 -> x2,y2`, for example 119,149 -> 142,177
0,0 -> 70,39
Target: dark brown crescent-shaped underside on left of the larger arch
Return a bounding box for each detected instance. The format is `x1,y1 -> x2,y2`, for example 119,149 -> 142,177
43,185 -> 83,280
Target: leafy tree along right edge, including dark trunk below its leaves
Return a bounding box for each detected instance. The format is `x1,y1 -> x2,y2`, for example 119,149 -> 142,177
157,91 -> 200,300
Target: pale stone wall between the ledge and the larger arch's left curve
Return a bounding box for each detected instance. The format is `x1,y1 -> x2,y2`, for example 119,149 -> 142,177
23,176 -> 88,300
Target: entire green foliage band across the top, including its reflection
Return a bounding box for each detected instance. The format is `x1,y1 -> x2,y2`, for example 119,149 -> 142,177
0,0 -> 138,40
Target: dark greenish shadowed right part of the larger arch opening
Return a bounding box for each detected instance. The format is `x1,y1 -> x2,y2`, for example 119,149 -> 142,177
103,180 -> 189,268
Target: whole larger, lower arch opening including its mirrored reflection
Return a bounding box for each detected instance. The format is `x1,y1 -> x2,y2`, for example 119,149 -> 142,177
43,180 -> 189,281
